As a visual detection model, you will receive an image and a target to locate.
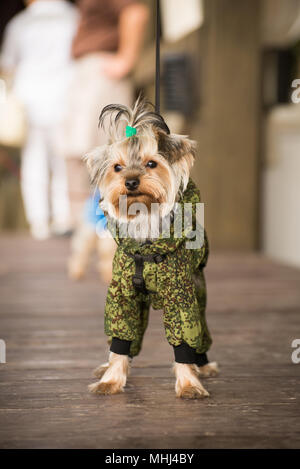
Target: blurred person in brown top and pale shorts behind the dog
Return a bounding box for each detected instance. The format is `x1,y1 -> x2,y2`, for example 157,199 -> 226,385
64,0 -> 149,281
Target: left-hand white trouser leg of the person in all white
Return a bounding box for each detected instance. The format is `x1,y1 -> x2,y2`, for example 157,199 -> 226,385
21,128 -> 50,239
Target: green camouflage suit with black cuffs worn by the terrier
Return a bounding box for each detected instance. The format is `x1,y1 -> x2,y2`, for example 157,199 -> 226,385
105,179 -> 212,365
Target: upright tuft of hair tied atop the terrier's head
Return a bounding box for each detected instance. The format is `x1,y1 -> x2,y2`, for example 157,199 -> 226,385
99,95 -> 170,141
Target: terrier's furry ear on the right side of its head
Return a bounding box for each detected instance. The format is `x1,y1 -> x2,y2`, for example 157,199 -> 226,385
155,129 -> 196,168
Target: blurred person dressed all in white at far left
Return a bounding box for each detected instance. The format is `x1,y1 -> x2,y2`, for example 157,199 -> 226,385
1,0 -> 78,239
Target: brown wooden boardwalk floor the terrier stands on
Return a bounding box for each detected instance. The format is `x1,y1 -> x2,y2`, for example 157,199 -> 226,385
0,236 -> 300,449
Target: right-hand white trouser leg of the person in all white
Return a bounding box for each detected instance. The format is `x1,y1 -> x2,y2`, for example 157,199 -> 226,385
48,127 -> 71,234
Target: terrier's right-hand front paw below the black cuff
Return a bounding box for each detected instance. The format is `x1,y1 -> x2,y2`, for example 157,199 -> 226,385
174,362 -> 209,399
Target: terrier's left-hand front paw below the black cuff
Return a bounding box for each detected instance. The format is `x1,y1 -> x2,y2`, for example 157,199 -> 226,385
89,352 -> 129,394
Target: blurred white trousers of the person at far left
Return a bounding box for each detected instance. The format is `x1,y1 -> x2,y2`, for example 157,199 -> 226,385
21,126 -> 70,229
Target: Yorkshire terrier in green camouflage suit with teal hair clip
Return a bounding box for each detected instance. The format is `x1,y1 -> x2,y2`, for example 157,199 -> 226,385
85,98 -> 218,399
